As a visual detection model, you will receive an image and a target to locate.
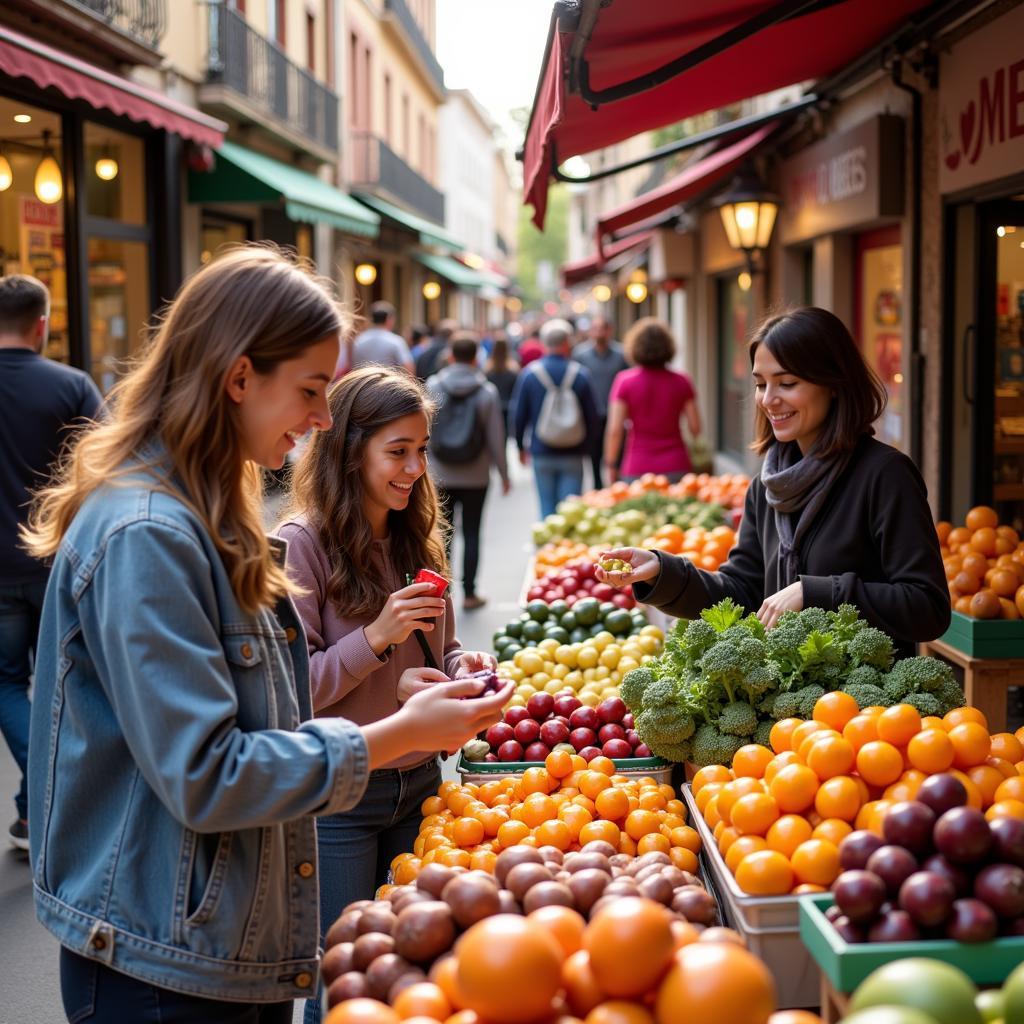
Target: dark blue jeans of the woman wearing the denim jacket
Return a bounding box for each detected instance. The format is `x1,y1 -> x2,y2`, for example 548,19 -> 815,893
60,946 -> 292,1024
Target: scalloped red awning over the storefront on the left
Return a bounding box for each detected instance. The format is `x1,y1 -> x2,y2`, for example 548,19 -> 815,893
0,25 -> 227,147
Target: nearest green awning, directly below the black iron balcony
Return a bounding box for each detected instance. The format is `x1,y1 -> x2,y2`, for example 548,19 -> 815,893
188,142 -> 381,239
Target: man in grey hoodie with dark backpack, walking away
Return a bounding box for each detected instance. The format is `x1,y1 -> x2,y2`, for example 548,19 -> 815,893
427,331 -> 511,609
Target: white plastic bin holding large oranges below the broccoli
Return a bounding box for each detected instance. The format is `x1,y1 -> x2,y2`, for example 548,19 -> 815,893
682,783 -> 820,1010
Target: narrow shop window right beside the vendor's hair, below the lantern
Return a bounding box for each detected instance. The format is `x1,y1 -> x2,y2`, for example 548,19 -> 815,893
716,274 -> 754,463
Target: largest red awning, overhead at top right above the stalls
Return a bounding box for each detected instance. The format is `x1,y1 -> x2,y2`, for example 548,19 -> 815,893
523,0 -> 928,226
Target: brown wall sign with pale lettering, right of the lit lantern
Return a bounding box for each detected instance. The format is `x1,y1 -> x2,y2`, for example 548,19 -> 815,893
779,114 -> 903,245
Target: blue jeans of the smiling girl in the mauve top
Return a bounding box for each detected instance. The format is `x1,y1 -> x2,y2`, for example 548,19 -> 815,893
302,760 -> 441,1024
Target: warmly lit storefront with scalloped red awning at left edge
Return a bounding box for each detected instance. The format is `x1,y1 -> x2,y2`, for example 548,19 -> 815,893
0,27 -> 224,392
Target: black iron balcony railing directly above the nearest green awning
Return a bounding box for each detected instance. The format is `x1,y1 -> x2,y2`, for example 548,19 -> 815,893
207,0 -> 338,152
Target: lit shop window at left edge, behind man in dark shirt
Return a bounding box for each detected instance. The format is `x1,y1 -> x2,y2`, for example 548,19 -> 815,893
0,96 -> 70,362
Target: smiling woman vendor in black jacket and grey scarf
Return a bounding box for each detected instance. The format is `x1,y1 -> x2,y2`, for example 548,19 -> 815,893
598,307 -> 949,656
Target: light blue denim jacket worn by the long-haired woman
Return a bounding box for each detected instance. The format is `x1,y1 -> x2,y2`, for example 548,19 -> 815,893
29,468 -> 368,1001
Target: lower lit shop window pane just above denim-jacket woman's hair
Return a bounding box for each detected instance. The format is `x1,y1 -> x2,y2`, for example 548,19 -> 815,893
88,238 -> 151,393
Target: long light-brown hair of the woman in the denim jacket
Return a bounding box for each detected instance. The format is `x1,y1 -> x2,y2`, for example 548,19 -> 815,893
22,245 -> 345,612
